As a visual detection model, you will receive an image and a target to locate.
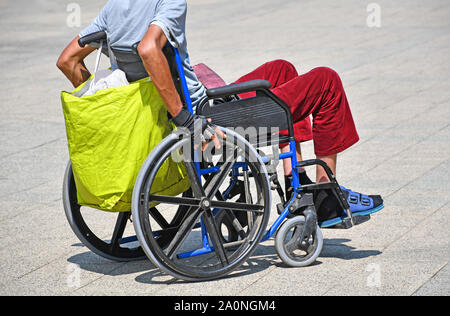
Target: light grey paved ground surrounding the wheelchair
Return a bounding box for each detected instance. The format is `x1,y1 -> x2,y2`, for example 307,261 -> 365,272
0,0 -> 450,295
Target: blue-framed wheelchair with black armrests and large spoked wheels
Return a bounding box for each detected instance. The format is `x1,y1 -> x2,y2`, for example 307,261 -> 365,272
63,32 -> 370,281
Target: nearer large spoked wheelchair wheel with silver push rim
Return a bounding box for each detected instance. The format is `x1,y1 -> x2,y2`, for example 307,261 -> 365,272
132,129 -> 271,281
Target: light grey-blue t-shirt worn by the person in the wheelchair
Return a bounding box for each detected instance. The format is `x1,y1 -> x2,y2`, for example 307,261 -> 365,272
80,0 -> 206,107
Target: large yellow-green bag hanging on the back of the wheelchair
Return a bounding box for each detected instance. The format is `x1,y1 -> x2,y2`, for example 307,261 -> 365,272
61,77 -> 189,212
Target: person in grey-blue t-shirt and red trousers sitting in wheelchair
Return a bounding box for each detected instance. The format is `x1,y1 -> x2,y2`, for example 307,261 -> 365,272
57,0 -> 383,227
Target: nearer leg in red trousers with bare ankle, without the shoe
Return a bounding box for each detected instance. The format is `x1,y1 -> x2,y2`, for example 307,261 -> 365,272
272,67 -> 359,182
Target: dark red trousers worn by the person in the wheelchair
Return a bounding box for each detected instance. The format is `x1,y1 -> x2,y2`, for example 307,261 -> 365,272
234,60 -> 359,156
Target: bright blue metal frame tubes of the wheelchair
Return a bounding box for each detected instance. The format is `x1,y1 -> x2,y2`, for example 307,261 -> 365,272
168,47 -> 301,258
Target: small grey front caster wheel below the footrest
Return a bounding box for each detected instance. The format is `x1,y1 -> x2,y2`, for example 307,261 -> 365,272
275,216 -> 323,267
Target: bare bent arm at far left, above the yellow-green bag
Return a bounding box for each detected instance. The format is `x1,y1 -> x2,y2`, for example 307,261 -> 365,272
56,36 -> 95,87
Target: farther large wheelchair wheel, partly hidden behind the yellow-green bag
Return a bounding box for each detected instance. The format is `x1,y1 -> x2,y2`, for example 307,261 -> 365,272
63,161 -> 185,262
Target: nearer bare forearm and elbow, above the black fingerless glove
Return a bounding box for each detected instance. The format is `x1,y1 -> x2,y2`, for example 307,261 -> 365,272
138,25 -> 183,117
